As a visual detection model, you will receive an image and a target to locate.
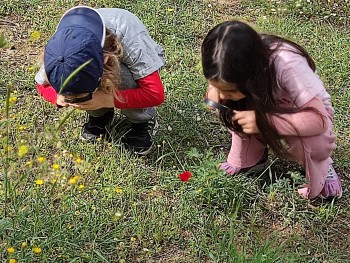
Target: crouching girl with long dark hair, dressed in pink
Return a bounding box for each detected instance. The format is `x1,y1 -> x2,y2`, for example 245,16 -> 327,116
201,21 -> 342,199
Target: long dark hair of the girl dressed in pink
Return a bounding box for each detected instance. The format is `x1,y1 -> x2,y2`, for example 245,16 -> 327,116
201,20 -> 315,157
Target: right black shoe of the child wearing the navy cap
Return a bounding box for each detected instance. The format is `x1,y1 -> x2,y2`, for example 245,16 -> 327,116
123,118 -> 158,155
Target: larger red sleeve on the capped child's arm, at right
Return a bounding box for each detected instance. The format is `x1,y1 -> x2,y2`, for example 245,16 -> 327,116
114,71 -> 165,109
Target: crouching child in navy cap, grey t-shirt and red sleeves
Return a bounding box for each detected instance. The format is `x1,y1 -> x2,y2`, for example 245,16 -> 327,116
35,6 -> 165,155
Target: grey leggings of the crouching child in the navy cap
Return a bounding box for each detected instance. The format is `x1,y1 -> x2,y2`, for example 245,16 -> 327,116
87,64 -> 157,123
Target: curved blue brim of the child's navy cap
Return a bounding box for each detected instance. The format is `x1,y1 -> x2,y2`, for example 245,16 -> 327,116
56,6 -> 106,47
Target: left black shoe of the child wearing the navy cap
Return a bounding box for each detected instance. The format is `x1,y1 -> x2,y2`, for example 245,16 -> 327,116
80,111 -> 114,142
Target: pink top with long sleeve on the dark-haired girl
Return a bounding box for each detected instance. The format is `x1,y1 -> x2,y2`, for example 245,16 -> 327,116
269,44 -> 334,137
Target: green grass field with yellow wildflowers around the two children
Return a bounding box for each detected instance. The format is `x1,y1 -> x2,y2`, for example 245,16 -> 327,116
0,0 -> 350,263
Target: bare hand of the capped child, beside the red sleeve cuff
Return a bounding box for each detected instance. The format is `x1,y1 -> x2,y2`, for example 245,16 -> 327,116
69,90 -> 114,110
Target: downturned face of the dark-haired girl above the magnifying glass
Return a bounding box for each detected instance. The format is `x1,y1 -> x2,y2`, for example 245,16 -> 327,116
208,80 -> 245,101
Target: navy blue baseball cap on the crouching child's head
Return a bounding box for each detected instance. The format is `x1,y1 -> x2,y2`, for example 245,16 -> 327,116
44,6 -> 106,94
